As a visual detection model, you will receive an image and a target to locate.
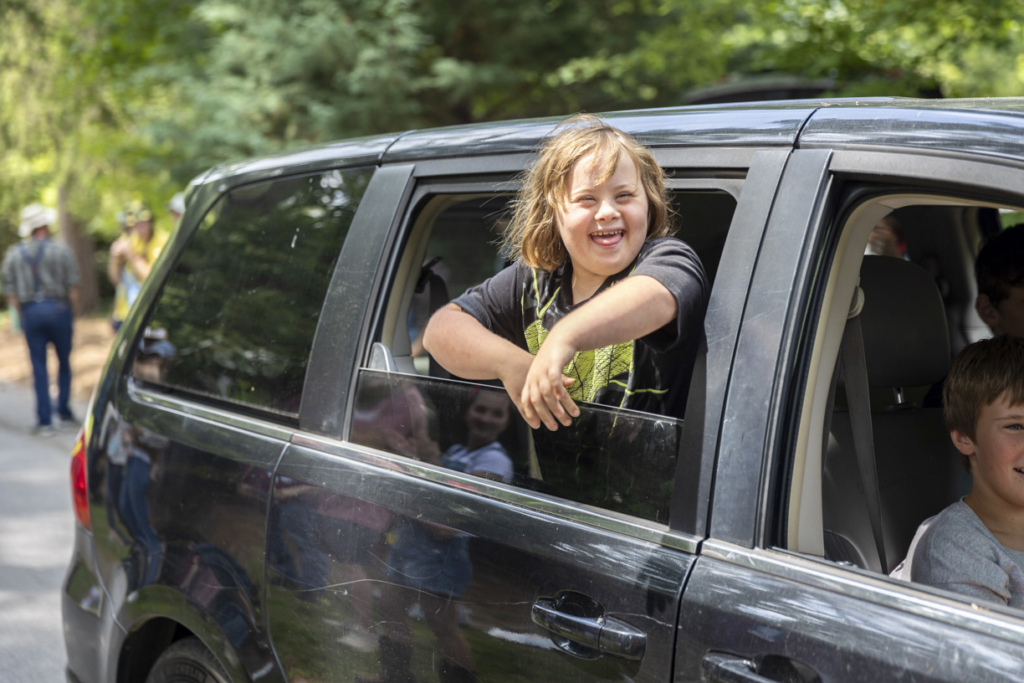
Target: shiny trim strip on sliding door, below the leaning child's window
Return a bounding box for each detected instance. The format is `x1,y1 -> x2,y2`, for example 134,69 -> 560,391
291,431 -> 700,554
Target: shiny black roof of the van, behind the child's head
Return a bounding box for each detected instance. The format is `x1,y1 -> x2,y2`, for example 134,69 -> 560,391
193,97 -> 1024,188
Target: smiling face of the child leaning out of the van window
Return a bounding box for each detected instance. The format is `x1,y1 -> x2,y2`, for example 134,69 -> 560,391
558,154 -> 647,303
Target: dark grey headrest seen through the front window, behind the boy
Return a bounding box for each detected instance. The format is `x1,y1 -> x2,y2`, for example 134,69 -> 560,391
860,256 -> 950,387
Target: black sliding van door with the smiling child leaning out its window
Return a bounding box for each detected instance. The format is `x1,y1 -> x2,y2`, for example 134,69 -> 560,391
267,148 -> 788,681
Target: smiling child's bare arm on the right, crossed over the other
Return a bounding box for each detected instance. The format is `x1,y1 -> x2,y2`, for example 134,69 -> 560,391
520,275 -> 679,431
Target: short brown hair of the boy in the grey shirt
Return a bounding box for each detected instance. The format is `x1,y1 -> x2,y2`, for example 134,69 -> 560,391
942,335 -> 1024,471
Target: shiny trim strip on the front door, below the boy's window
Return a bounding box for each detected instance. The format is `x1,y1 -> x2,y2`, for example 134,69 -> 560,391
700,539 -> 1024,643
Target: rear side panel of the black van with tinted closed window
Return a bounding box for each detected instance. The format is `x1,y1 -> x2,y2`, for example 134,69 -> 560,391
90,167 -> 373,680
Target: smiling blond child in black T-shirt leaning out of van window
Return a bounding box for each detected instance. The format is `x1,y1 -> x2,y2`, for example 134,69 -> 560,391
424,115 -> 709,430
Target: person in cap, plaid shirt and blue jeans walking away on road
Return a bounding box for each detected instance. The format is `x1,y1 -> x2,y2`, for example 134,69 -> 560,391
2,204 -> 79,435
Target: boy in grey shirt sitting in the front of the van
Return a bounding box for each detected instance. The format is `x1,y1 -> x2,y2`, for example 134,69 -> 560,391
903,335 -> 1024,607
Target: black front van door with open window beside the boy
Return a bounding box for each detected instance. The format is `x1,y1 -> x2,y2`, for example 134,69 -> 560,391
675,125 -> 1024,682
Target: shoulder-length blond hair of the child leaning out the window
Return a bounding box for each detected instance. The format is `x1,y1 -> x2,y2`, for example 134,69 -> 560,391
503,114 -> 672,271
